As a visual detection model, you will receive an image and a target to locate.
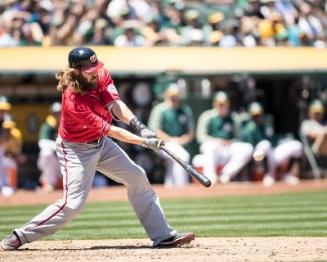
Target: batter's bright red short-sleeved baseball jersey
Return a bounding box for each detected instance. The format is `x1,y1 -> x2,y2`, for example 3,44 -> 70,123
58,68 -> 120,143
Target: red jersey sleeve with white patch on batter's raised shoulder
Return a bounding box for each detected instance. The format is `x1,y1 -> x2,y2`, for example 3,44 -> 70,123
98,69 -> 120,106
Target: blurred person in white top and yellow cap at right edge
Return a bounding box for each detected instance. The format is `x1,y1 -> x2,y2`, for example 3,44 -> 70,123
300,99 -> 327,156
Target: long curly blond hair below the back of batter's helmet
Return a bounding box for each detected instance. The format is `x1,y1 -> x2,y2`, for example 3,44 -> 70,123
56,67 -> 85,94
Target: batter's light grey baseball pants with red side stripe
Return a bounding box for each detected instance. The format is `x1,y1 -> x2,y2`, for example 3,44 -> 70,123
15,137 -> 176,245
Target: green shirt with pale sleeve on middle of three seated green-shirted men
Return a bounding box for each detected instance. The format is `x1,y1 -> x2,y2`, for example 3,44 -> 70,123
196,109 -> 236,143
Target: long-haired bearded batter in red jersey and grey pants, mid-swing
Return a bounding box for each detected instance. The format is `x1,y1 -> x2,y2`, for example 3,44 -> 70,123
1,47 -> 194,250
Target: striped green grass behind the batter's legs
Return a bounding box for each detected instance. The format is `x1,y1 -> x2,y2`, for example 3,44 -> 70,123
0,189 -> 327,240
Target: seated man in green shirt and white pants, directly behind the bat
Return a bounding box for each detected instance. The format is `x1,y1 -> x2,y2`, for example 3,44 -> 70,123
148,84 -> 194,186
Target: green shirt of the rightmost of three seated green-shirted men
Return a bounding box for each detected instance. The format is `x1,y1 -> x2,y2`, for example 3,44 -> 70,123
242,117 -> 277,146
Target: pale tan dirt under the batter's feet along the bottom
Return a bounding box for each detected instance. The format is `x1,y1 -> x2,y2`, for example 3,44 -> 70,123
0,237 -> 327,262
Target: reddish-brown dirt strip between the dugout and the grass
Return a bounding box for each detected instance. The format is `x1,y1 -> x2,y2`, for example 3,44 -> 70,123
0,180 -> 327,207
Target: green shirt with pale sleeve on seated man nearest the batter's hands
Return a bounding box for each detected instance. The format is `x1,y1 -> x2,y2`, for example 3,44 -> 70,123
148,103 -> 194,136
